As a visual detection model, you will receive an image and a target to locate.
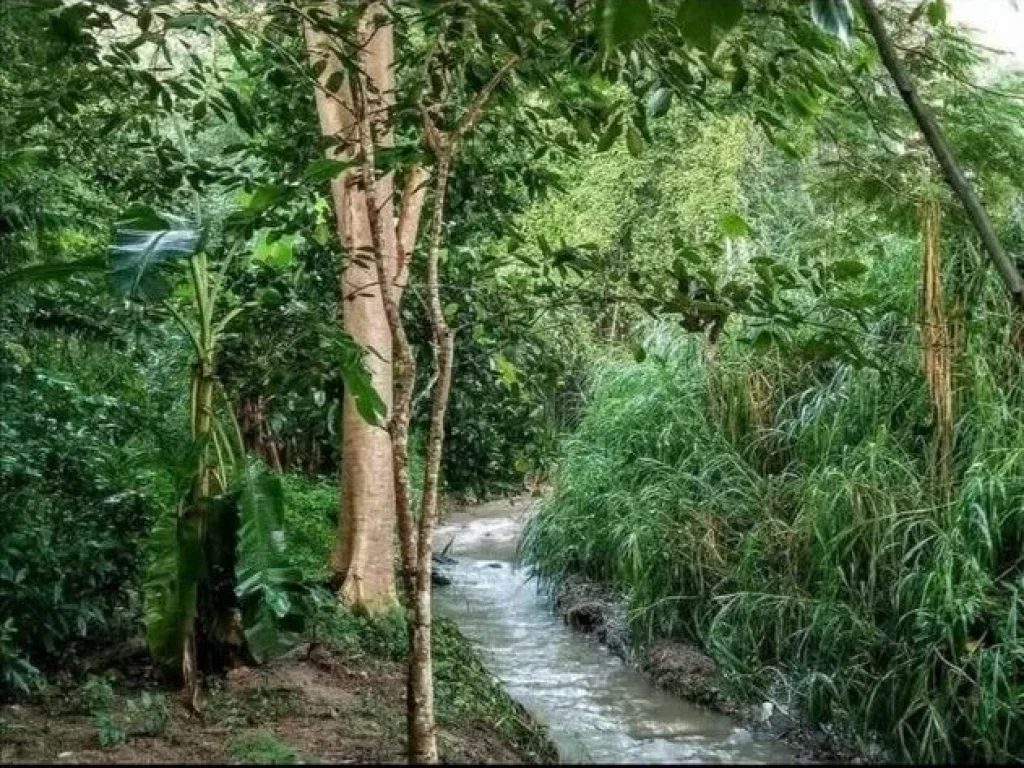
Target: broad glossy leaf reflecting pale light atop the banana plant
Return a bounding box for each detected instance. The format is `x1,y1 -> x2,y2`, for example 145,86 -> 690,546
110,206 -> 202,299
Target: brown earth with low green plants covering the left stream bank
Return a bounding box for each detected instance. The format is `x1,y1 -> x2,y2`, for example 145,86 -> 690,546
0,627 -> 555,764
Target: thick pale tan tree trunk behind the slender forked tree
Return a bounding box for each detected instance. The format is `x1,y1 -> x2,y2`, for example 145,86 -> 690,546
306,3 -> 397,612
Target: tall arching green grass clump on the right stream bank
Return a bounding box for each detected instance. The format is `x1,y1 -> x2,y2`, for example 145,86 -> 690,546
525,321 -> 1024,762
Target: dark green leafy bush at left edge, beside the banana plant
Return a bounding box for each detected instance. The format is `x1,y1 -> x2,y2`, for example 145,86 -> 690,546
0,333 -> 168,690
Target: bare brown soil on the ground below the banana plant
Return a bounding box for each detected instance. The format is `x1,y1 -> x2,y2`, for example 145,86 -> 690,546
0,644 -> 552,764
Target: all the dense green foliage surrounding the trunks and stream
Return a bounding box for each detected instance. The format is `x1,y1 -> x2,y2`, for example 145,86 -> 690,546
0,0 -> 1024,761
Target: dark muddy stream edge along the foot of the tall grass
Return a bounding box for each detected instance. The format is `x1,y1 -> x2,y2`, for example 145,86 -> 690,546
553,577 -> 881,763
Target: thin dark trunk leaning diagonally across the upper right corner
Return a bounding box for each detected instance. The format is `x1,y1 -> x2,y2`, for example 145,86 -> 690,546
860,0 -> 1024,307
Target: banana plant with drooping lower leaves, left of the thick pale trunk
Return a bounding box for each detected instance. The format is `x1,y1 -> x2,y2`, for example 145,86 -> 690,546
109,207 -> 319,709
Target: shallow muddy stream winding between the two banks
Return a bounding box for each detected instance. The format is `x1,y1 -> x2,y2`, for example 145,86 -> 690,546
434,500 -> 794,763
